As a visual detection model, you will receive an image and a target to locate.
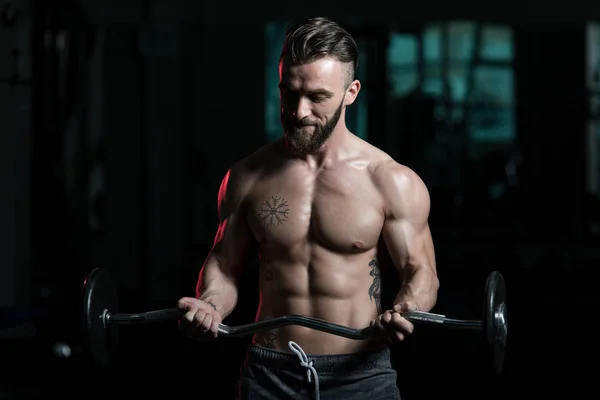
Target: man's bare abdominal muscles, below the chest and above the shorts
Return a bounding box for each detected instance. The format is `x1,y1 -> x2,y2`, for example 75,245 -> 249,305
253,250 -> 383,355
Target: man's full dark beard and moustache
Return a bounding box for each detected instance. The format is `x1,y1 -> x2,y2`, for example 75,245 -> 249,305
281,101 -> 344,156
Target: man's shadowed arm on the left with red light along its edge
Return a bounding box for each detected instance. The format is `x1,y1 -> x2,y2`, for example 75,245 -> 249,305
196,164 -> 251,319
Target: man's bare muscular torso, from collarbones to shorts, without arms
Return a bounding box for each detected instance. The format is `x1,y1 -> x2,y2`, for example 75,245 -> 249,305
244,137 -> 396,354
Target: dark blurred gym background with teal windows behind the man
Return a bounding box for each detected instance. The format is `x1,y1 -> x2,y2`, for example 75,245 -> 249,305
0,0 -> 600,400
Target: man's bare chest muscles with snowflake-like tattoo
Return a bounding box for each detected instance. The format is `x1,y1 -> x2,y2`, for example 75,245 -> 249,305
248,166 -> 383,253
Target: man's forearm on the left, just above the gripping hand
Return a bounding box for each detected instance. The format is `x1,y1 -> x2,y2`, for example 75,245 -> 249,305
196,257 -> 238,319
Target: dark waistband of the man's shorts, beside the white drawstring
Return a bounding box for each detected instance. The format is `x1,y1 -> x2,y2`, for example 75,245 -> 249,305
246,345 -> 392,373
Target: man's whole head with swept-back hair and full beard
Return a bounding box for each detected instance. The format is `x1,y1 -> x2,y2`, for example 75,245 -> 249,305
279,18 -> 360,155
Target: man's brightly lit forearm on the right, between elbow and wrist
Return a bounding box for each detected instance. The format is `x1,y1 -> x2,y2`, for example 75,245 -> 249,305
394,266 -> 440,311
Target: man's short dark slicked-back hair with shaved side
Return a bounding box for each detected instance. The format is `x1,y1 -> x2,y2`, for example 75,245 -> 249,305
280,17 -> 358,85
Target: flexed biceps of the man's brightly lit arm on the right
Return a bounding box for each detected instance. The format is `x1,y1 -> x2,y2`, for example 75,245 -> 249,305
383,220 -> 436,270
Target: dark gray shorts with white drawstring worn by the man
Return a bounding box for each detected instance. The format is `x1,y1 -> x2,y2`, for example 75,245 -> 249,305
237,346 -> 400,400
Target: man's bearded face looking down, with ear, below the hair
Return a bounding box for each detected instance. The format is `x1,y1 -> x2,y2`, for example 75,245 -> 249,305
279,58 -> 360,155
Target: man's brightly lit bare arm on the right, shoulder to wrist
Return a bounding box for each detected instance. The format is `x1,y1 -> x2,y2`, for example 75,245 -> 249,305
378,162 -> 439,313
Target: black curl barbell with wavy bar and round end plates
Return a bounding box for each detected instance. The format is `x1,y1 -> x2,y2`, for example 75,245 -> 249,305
83,268 -> 508,374
